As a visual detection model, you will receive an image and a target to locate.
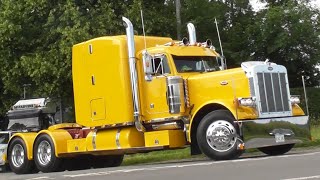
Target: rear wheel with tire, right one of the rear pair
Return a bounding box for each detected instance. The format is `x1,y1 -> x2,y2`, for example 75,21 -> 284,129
33,134 -> 62,173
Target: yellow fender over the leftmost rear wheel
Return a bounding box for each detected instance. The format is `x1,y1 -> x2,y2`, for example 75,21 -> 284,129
9,132 -> 37,160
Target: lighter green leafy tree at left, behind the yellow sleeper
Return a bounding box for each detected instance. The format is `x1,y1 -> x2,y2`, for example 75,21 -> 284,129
0,0 -> 120,112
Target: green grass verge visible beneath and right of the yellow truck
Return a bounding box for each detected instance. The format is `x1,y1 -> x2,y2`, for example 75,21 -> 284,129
122,126 -> 320,165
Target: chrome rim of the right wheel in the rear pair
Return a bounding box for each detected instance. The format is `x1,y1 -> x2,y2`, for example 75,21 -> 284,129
37,141 -> 51,166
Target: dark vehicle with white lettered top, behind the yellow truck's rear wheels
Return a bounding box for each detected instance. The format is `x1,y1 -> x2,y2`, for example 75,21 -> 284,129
0,98 -> 57,171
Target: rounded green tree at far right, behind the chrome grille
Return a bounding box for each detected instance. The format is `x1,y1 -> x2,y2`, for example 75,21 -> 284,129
250,1 -> 320,87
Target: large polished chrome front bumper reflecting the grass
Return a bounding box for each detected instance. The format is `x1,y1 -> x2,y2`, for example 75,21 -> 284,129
238,116 -> 311,149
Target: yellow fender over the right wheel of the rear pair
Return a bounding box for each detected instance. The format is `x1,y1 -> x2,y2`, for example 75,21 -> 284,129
36,129 -> 73,157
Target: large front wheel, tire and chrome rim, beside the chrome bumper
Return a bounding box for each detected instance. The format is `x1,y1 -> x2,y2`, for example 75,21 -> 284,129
197,110 -> 241,160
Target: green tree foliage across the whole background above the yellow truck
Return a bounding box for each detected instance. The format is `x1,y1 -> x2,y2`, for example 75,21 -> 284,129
0,0 -> 320,114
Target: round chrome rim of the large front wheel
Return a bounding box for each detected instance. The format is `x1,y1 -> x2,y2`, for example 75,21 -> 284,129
206,120 -> 237,152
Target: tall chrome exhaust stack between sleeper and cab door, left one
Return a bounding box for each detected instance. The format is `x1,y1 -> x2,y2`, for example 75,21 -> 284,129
122,17 -> 145,132
